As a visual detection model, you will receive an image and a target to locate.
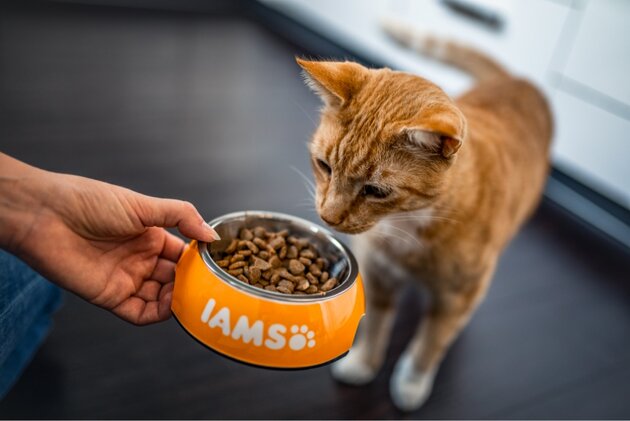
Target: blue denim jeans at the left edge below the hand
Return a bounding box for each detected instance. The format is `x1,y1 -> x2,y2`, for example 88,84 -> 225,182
0,249 -> 61,399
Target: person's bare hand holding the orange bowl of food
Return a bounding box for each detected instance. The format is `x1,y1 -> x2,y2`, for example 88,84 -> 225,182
0,154 -> 218,325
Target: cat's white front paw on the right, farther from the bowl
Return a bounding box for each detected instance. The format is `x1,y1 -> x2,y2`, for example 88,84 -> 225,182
389,353 -> 435,411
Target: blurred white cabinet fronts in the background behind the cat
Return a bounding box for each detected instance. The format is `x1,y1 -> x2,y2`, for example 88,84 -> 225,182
262,0 -> 630,208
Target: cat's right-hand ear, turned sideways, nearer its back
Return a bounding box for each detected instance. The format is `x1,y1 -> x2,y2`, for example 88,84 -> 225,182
402,104 -> 466,158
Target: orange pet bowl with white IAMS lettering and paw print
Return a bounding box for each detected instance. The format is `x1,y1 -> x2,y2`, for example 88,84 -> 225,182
171,211 -> 365,369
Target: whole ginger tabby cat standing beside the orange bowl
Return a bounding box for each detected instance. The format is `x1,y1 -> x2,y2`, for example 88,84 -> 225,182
297,24 -> 552,410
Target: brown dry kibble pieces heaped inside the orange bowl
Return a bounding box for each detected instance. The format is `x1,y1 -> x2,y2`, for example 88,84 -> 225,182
215,227 -> 339,295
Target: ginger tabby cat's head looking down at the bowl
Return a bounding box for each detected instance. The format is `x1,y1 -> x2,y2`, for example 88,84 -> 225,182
297,59 -> 466,233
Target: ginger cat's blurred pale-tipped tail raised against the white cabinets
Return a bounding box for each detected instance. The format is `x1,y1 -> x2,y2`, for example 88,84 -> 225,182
381,18 -> 509,80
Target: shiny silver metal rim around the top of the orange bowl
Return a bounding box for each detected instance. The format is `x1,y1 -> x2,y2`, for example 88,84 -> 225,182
198,211 -> 359,303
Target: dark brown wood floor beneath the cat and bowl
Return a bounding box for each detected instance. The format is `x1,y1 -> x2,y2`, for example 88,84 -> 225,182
0,3 -> 630,418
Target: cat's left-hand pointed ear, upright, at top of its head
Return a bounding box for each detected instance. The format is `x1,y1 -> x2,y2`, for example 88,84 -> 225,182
295,57 -> 369,106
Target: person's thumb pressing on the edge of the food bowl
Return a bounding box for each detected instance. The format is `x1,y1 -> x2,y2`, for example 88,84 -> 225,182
140,196 -> 221,243
